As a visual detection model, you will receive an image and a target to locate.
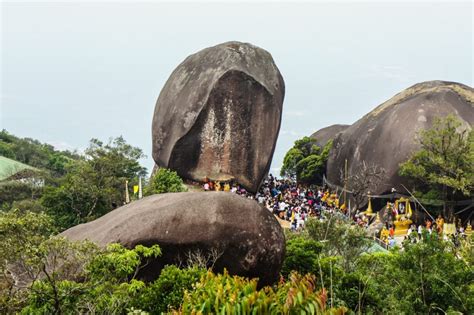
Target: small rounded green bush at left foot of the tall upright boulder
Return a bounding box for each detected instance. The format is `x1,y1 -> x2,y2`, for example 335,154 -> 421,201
145,168 -> 186,196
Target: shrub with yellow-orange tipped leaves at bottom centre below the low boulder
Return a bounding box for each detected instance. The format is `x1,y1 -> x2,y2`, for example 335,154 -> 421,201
180,271 -> 344,314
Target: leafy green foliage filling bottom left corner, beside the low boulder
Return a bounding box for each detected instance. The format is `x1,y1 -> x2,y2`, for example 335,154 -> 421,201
0,211 -> 161,314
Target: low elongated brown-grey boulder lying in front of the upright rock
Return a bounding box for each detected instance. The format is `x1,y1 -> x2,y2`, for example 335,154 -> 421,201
62,192 -> 285,285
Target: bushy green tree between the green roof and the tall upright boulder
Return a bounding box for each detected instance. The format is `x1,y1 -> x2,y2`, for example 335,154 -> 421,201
42,137 -> 146,229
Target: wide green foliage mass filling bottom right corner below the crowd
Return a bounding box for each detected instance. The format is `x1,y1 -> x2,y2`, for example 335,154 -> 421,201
284,222 -> 474,314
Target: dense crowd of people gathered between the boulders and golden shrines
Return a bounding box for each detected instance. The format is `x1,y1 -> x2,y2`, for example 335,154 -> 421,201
203,174 -> 471,247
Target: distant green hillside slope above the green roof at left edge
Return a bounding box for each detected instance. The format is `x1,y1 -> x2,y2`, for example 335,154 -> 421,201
0,130 -> 79,176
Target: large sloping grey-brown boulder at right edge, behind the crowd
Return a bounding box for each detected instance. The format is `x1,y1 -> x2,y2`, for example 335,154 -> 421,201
327,81 -> 474,194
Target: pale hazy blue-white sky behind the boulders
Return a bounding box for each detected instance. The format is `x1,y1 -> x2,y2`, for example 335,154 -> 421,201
0,1 -> 474,171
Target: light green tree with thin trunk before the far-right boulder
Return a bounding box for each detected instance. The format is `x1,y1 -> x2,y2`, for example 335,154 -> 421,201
400,115 -> 474,218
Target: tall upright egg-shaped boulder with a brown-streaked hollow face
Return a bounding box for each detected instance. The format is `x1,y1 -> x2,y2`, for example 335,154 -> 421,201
152,42 -> 285,192
